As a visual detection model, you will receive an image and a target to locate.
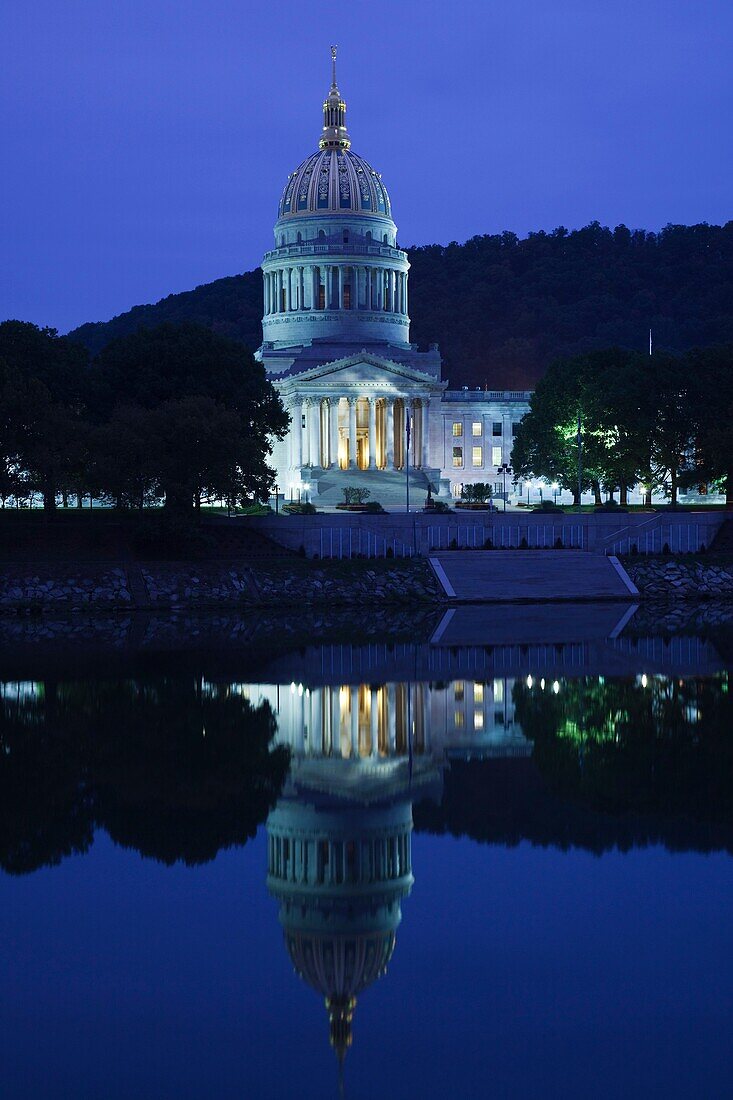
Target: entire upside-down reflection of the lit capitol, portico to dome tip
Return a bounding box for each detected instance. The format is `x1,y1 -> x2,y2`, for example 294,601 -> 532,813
240,679 -> 529,1062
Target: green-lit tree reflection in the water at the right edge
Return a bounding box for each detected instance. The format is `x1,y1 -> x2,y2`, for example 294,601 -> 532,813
514,675 -> 733,824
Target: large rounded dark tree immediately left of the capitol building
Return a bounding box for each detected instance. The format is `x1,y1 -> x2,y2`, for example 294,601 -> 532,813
94,325 -> 288,510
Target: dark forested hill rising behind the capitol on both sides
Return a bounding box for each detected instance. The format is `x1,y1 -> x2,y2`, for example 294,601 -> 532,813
73,221 -> 733,388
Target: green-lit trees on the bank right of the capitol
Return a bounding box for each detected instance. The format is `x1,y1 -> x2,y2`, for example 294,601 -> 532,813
512,344 -> 733,503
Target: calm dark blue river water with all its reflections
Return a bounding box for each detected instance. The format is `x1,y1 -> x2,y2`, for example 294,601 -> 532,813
0,606 -> 733,1100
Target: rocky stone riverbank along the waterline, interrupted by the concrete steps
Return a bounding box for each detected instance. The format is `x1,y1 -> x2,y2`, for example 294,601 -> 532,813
0,550 -> 733,615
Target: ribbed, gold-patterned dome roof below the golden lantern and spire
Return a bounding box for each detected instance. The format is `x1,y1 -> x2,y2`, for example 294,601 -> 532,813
277,147 -> 392,218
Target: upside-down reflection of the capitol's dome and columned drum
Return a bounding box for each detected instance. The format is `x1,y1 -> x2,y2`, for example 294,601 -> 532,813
267,798 -> 413,1060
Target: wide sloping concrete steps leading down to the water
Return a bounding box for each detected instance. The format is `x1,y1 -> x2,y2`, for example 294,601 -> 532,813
430,550 -> 638,603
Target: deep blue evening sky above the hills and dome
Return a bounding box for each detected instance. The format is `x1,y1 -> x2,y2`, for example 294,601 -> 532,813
0,0 -> 733,331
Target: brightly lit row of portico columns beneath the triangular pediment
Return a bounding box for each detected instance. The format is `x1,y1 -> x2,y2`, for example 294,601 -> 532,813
288,395 -> 429,470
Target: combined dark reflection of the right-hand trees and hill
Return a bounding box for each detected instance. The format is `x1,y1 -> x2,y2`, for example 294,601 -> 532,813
414,675 -> 733,853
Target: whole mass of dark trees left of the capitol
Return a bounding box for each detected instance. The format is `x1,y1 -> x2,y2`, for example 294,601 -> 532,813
0,321 -> 288,510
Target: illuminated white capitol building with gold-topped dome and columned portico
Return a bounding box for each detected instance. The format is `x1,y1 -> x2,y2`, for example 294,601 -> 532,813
256,47 -> 530,507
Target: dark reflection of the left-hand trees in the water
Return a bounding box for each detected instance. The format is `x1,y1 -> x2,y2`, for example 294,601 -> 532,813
0,678 -> 288,872
